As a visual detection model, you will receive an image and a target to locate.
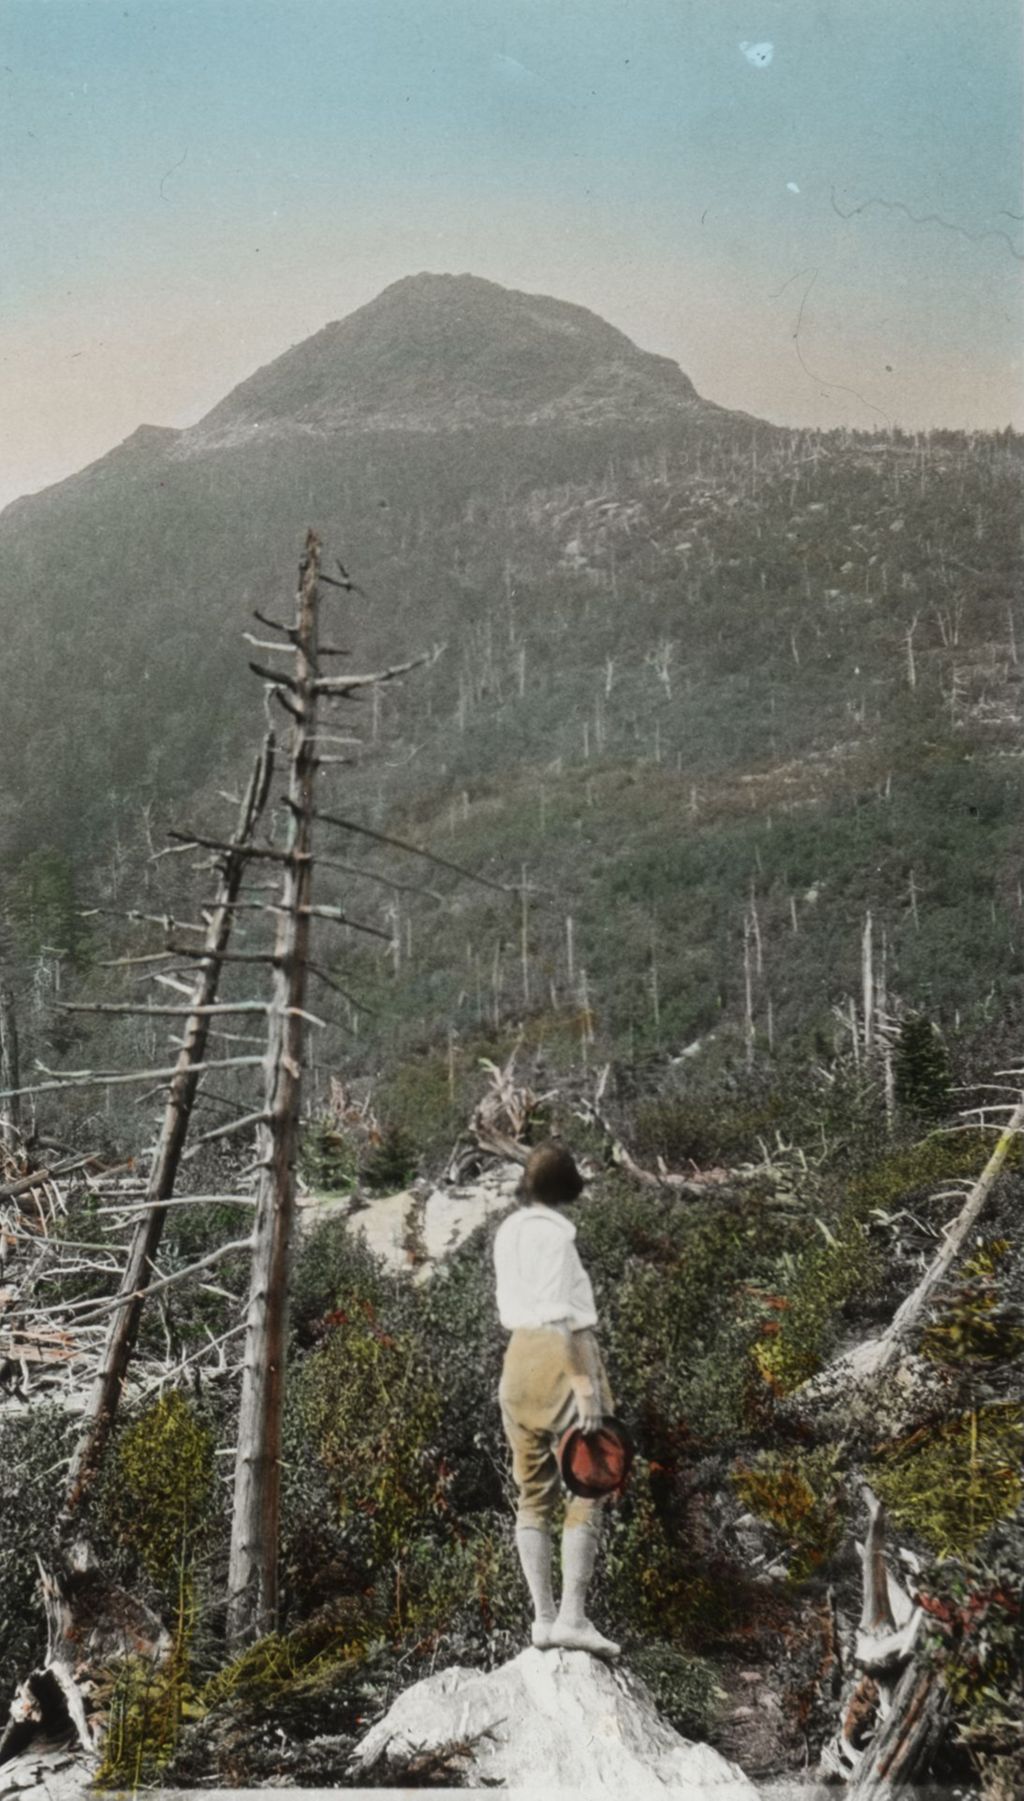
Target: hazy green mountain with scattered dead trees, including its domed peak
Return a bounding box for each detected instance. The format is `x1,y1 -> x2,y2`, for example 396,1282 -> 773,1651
0,277 -> 1024,1054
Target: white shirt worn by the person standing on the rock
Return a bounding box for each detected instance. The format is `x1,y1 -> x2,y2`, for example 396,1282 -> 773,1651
495,1201 -> 597,1331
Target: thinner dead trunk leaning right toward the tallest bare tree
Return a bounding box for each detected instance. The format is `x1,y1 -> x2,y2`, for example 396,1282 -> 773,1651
65,737 -> 274,1522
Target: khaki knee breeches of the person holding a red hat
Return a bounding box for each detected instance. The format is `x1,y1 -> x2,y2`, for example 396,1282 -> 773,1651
499,1326 -> 614,1529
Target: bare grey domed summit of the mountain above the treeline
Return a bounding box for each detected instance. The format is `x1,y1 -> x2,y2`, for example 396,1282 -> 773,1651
185,274 -> 705,448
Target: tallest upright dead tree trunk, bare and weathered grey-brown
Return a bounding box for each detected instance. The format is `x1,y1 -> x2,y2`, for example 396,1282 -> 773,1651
227,531 -> 320,1644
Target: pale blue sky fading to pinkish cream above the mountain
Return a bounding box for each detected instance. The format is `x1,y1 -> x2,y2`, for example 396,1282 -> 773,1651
0,0 -> 1024,499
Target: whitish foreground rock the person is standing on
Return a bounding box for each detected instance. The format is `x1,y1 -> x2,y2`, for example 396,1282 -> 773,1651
353,1650 -> 758,1801
